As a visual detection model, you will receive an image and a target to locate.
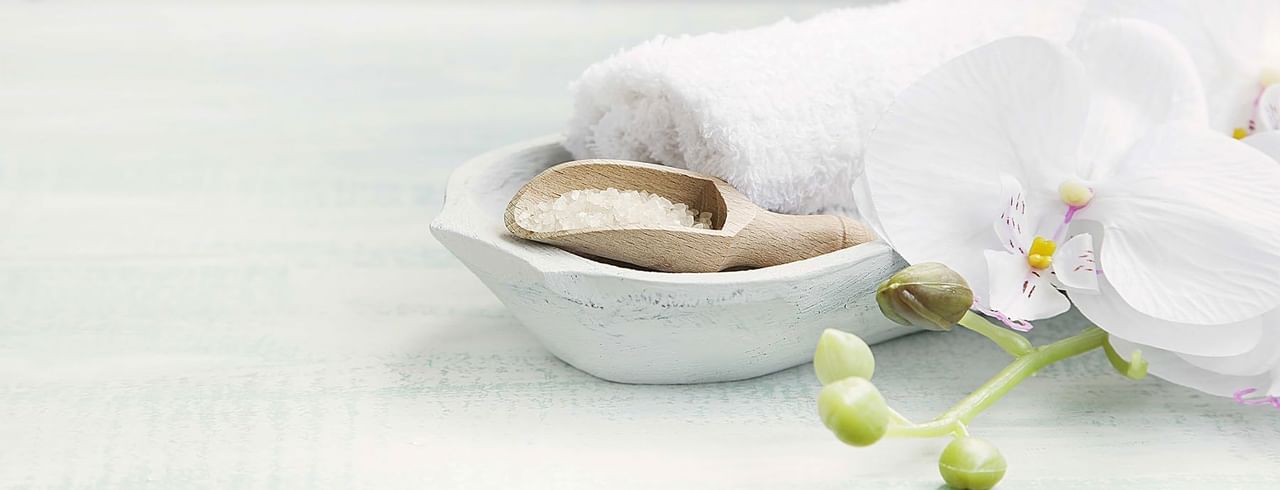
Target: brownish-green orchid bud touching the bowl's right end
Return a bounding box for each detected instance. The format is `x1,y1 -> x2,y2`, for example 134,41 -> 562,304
876,262 -> 973,330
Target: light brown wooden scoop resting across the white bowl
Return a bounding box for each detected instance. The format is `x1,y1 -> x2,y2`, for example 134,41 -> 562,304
506,160 -> 876,273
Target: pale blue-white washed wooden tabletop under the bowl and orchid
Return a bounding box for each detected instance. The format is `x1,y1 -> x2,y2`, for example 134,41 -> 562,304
0,1 -> 1280,489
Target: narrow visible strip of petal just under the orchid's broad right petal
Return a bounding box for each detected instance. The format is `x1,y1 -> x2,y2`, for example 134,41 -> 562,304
1071,276 -> 1275,357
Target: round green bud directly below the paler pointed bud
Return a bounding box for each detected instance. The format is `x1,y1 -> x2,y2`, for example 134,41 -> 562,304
818,377 -> 890,447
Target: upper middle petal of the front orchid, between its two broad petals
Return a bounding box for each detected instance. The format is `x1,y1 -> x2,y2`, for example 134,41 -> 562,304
1073,20 -> 1207,178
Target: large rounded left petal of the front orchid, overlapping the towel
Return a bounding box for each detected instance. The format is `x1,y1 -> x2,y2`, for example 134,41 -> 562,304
864,37 -> 1088,289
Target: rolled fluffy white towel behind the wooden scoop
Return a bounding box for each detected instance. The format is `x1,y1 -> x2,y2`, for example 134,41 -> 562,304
566,0 -> 1083,215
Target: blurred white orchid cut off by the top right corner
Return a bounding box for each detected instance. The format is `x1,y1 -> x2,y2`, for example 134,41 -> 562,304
1083,0 -> 1280,149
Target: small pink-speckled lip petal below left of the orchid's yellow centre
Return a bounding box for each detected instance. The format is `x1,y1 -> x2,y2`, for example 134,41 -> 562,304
986,251 -> 1071,320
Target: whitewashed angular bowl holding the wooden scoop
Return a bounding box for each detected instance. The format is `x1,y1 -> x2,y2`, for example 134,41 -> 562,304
431,137 -> 913,384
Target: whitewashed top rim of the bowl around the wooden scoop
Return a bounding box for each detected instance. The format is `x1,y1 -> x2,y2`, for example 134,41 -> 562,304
430,133 -> 892,285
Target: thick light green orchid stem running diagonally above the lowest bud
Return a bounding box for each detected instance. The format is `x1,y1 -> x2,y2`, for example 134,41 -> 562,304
888,327 -> 1107,438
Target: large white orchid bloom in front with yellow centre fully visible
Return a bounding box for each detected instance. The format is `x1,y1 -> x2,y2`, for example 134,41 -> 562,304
858,20 -> 1280,404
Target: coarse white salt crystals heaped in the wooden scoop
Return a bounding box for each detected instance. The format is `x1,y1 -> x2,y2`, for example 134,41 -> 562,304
516,187 -> 712,232
